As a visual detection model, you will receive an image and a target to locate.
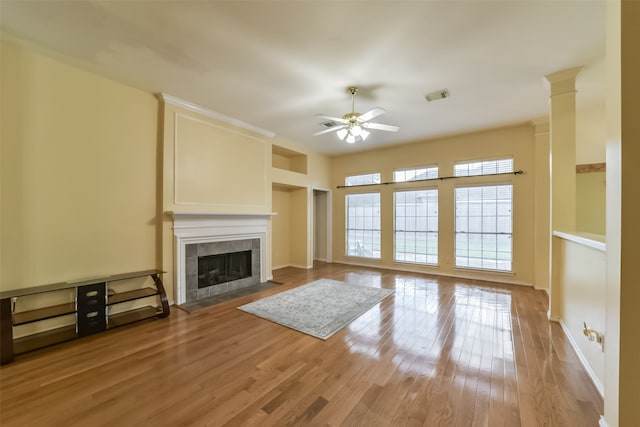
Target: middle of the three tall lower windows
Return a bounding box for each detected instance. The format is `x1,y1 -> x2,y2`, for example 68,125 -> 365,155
393,189 -> 438,264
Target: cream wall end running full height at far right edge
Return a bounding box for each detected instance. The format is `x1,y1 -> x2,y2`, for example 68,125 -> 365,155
601,0 -> 640,427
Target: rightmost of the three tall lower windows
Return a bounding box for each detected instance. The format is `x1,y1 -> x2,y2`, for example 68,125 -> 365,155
455,184 -> 513,271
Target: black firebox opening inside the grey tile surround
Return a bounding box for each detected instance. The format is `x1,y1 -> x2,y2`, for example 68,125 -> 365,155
198,250 -> 251,289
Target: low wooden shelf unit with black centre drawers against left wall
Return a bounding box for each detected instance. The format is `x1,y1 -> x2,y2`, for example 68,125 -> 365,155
0,270 -> 170,364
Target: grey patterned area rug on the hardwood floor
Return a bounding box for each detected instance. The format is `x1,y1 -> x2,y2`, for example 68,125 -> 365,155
238,279 -> 393,340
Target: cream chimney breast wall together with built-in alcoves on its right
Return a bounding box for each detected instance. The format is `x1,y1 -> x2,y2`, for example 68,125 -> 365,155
161,100 -> 331,292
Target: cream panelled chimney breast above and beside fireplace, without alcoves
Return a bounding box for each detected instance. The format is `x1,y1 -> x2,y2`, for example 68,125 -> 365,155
160,100 -> 271,301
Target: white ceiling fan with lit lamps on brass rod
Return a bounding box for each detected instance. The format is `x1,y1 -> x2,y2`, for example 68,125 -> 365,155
313,87 -> 400,144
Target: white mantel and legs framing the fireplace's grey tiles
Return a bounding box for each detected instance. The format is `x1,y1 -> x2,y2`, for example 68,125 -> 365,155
171,212 -> 275,304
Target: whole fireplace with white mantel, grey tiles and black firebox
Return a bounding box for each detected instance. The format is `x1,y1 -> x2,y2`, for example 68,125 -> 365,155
173,212 -> 272,304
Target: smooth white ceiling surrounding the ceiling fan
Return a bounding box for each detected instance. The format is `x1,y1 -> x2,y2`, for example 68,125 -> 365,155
0,0 -> 605,154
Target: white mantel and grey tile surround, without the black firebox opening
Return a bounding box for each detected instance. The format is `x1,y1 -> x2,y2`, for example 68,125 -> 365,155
173,212 -> 271,304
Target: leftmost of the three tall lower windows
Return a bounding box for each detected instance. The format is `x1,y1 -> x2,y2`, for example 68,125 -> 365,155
346,193 -> 380,259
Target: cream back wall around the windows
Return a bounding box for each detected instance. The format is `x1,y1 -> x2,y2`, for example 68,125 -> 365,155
333,124 -> 535,285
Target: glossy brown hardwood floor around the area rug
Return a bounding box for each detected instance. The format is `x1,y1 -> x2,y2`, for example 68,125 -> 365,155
0,263 -> 603,427
